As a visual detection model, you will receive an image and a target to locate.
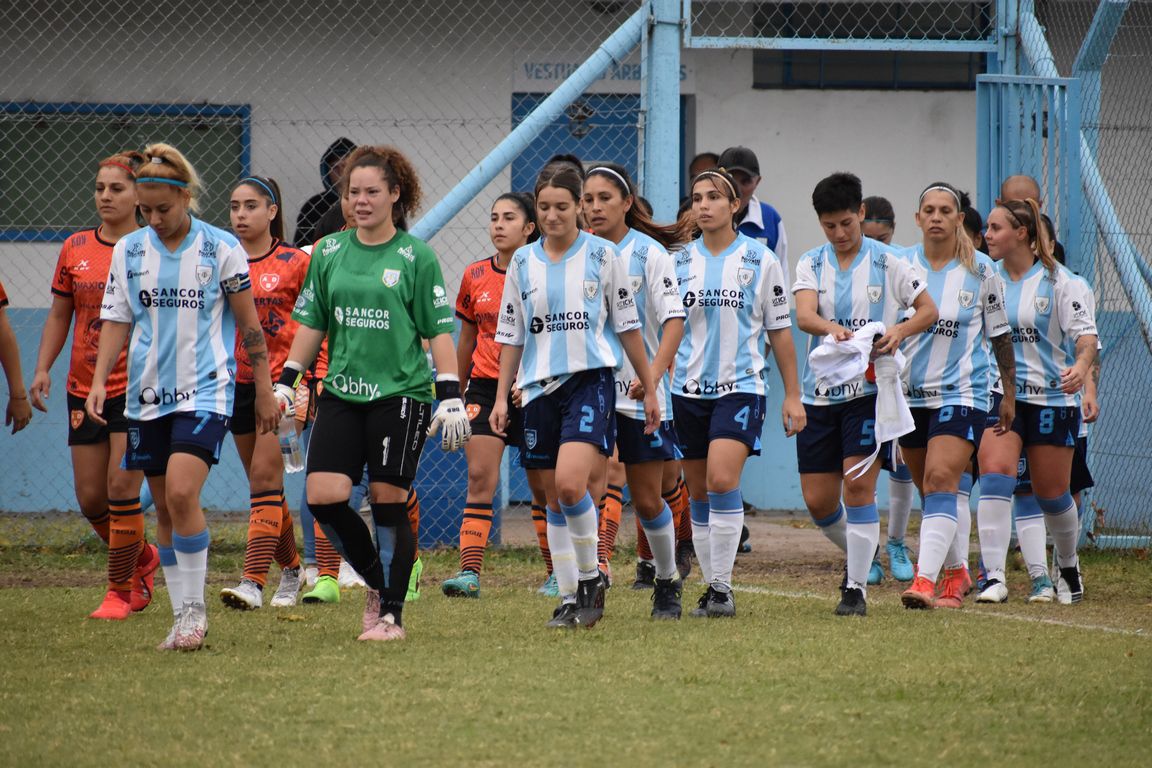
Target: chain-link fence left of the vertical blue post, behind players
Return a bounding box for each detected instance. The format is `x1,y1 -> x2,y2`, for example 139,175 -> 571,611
0,0 -> 642,546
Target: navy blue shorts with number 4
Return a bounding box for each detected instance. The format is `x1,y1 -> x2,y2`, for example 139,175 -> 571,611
672,393 -> 767,459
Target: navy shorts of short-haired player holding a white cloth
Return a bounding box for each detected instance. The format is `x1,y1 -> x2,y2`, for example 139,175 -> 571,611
796,395 -> 876,474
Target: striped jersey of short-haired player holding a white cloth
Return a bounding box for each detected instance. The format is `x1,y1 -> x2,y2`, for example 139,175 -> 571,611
793,237 -> 926,405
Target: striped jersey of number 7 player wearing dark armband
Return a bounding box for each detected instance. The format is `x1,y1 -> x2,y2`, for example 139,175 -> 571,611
100,219 -> 251,421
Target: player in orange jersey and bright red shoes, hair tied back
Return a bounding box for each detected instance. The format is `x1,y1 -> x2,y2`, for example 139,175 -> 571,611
30,152 -> 160,619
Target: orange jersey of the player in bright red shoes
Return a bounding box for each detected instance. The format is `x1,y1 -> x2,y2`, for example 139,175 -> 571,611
52,228 -> 128,397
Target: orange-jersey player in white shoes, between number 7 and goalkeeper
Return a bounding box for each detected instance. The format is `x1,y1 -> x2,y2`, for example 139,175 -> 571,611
220,176 -> 309,610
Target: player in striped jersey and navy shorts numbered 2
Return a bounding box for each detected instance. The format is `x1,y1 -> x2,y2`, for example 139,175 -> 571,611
490,164 -> 660,628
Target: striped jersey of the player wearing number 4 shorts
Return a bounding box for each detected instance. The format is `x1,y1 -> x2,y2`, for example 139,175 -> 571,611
672,234 -> 791,400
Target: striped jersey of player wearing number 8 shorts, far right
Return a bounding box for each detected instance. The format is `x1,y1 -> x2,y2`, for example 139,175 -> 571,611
993,259 -> 1098,406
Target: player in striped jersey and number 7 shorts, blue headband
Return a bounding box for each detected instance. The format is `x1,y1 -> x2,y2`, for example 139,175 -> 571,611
85,144 -> 276,651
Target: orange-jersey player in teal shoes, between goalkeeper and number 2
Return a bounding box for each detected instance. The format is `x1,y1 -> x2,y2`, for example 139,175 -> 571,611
440,192 -> 552,598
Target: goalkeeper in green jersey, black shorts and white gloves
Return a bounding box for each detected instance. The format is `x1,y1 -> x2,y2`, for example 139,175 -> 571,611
275,146 -> 471,640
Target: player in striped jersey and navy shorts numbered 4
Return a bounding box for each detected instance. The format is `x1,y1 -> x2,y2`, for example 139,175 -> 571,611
672,169 -> 806,618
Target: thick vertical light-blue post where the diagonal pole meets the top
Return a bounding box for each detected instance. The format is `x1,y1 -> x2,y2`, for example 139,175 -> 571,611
639,0 -> 682,221
